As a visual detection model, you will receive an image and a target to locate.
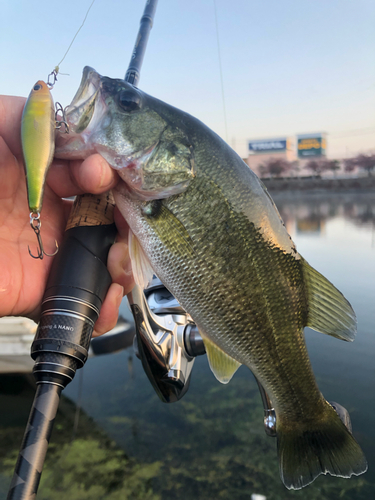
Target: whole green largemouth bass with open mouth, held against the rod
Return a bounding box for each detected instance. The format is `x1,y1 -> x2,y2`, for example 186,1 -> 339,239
56,67 -> 367,489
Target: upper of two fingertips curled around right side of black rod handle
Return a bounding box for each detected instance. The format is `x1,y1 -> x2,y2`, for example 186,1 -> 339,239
107,241 -> 134,295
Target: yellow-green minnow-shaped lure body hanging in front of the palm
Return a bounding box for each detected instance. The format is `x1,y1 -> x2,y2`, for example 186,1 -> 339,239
21,80 -> 56,214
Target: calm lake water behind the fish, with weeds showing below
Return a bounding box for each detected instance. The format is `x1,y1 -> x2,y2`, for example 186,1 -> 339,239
0,193 -> 375,500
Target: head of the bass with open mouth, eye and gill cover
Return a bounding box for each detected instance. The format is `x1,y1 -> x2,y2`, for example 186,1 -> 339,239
55,66 -> 194,200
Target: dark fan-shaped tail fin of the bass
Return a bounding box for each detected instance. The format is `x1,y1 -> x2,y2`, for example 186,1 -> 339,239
277,402 -> 367,490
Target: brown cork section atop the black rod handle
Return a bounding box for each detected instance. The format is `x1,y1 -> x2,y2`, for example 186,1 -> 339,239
66,191 -> 115,230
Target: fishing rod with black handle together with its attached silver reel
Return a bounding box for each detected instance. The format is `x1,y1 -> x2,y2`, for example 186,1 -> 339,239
7,0 -> 280,500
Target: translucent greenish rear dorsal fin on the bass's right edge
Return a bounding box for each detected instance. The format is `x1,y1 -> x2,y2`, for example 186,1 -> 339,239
302,259 -> 357,342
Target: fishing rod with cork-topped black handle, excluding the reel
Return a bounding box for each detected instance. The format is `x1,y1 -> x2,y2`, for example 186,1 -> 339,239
7,0 -> 157,500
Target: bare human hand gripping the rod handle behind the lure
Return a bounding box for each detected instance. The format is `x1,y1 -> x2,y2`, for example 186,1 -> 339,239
0,96 -> 134,335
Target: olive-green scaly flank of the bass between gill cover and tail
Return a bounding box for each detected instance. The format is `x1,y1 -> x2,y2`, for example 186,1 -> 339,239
145,170 -> 322,421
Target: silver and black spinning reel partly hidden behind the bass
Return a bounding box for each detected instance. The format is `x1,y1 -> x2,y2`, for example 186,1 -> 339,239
128,276 -> 276,436
